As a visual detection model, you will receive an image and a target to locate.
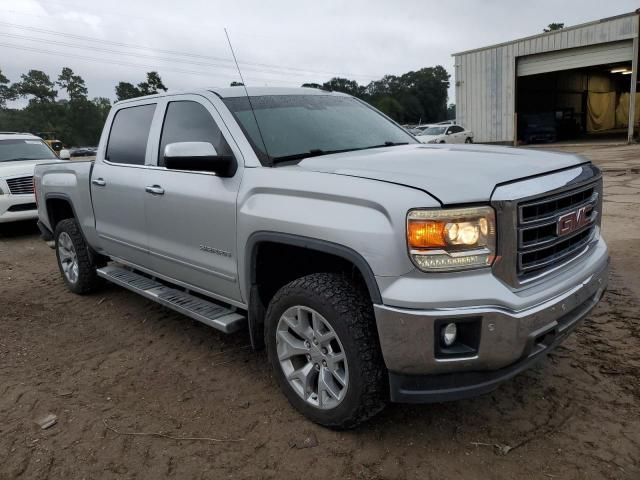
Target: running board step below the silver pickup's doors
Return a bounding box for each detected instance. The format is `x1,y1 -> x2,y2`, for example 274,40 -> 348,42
97,265 -> 247,333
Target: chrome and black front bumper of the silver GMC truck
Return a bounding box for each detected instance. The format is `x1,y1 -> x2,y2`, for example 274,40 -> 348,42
374,240 -> 609,403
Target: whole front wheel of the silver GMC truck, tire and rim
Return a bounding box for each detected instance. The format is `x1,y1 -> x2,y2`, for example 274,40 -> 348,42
265,273 -> 387,429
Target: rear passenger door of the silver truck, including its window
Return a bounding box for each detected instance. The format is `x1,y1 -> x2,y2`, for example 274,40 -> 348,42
91,103 -> 157,265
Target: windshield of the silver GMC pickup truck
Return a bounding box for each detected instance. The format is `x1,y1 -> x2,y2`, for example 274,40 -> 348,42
224,95 -> 417,164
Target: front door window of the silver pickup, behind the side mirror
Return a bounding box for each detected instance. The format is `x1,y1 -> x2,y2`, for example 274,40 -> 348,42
158,101 -> 233,166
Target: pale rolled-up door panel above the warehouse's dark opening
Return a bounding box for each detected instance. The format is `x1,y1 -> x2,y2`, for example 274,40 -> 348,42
517,40 -> 633,77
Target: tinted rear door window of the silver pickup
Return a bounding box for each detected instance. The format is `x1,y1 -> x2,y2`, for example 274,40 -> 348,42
105,104 -> 156,165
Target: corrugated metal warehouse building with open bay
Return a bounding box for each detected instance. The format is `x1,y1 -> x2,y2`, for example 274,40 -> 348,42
453,10 -> 640,143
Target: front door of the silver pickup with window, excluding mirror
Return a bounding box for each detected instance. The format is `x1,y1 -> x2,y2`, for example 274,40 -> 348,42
145,95 -> 243,301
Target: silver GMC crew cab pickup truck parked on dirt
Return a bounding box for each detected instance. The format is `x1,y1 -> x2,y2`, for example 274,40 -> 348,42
35,87 -> 609,428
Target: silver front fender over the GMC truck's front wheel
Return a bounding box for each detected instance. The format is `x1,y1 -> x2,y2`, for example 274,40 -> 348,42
238,166 -> 439,298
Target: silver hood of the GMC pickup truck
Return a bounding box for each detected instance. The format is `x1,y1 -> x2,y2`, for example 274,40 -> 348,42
298,144 -> 586,205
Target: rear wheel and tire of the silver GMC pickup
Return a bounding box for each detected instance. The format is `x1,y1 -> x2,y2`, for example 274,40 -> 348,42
54,218 -> 105,295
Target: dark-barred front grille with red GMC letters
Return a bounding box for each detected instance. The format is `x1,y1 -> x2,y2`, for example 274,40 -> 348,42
517,183 -> 601,279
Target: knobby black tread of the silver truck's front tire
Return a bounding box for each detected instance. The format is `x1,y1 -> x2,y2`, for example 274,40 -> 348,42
266,273 -> 388,429
